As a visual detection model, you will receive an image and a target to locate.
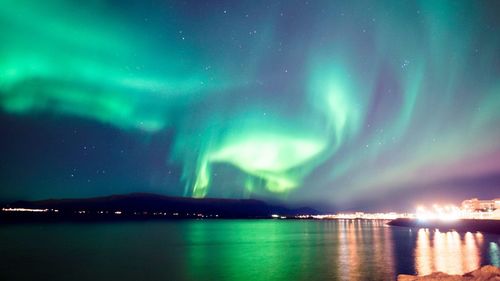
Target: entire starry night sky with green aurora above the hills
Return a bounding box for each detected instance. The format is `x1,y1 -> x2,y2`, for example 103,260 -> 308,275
0,0 -> 500,209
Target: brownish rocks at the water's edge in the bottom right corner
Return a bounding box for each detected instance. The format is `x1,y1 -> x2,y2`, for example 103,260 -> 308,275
398,265 -> 500,281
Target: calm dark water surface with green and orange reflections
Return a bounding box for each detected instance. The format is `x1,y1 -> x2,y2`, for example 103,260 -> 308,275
0,220 -> 500,281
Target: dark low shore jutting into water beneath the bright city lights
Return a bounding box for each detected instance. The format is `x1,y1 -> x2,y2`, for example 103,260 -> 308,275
388,218 -> 500,234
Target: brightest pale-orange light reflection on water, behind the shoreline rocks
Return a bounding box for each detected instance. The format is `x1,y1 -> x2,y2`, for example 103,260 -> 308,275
415,229 -> 488,275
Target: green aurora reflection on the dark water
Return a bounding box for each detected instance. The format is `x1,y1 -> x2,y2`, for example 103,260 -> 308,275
186,221 -> 336,281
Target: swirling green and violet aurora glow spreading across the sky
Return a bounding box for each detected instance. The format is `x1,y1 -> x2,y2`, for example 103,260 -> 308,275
0,0 -> 500,200
